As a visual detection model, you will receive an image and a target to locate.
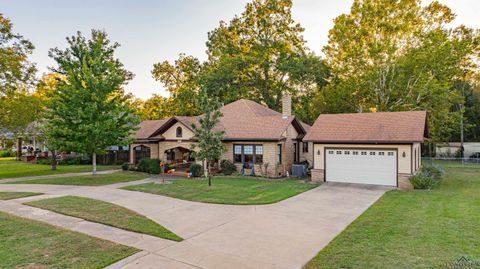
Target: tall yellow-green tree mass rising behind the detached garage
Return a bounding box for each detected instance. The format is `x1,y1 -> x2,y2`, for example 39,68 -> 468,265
322,0 -> 478,141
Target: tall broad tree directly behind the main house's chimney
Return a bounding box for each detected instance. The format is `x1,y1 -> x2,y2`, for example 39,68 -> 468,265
203,0 -> 327,122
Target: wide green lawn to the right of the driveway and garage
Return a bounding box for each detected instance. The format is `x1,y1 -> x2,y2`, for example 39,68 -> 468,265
306,163 -> 480,269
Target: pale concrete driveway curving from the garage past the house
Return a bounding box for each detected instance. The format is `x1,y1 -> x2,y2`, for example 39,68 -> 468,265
0,180 -> 390,268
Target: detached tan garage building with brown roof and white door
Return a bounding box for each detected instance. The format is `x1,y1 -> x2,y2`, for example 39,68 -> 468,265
304,111 -> 428,188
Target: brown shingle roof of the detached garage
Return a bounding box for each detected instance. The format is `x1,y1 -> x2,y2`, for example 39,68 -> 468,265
304,111 -> 427,143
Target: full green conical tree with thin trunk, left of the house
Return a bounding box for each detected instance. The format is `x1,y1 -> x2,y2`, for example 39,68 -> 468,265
47,30 -> 138,174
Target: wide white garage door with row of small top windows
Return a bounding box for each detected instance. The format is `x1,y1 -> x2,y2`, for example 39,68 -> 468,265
325,149 -> 397,186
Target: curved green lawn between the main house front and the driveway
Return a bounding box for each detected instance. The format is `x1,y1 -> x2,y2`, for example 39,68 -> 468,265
123,177 -> 318,205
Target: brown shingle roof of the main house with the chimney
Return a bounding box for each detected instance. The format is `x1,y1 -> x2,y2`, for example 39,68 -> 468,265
135,99 -> 310,140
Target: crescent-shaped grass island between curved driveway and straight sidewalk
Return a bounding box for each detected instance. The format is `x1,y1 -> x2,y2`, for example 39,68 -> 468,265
25,196 -> 183,241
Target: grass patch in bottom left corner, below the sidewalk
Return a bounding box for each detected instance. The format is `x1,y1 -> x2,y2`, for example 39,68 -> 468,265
0,212 -> 139,269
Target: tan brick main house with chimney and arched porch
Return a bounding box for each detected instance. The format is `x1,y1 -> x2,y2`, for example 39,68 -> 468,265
130,95 -> 312,177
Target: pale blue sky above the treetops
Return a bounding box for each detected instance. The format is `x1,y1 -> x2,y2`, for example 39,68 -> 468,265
0,0 -> 480,99
